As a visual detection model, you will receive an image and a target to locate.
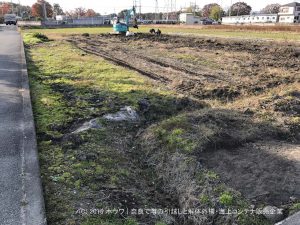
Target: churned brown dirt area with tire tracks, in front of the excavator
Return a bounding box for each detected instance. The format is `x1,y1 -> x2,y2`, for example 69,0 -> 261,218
72,34 -> 300,101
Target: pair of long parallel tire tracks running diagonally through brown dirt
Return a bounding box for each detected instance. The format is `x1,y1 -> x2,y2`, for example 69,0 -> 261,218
69,39 -> 237,99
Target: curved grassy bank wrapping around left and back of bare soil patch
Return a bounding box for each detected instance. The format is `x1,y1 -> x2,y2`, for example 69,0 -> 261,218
138,109 -> 288,224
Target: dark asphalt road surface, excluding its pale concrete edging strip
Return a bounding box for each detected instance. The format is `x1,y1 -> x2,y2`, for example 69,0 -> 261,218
0,24 -> 23,225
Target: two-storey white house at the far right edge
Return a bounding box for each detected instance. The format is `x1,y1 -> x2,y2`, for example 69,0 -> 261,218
278,2 -> 300,23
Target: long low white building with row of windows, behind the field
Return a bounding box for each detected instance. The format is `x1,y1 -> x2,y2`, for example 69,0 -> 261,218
222,14 -> 278,24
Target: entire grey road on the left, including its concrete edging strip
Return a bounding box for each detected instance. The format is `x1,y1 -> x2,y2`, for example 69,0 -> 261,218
0,26 -> 45,225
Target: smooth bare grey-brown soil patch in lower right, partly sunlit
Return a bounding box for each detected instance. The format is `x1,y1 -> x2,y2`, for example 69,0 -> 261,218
201,141 -> 300,206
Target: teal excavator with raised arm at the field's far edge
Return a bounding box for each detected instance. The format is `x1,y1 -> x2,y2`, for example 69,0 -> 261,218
113,6 -> 139,34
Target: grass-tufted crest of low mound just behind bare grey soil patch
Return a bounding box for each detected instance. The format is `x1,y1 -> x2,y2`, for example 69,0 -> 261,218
141,108 -> 285,155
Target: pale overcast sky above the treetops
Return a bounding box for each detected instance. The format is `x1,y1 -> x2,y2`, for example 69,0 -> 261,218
13,0 -> 295,14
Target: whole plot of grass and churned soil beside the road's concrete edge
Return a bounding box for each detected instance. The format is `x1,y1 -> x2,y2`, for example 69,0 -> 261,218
27,30 -> 300,225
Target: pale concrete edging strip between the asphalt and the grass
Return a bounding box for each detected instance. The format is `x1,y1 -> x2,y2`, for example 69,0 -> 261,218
20,33 -> 47,225
